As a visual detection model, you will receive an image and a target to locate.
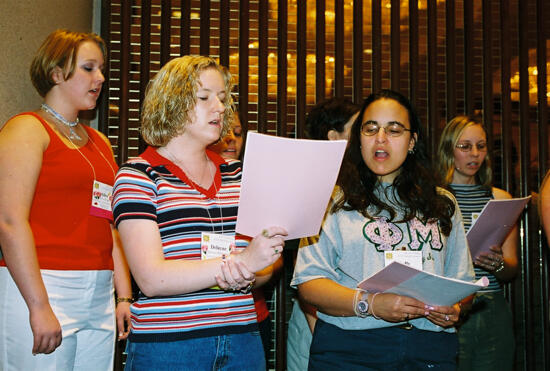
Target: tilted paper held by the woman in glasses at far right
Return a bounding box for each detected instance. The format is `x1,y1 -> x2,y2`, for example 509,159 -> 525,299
466,196 -> 531,259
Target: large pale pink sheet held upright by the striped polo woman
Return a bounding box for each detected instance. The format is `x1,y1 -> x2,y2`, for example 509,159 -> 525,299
236,133 -> 347,240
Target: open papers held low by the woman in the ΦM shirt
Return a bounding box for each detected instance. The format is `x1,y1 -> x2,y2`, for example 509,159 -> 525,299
357,262 -> 489,305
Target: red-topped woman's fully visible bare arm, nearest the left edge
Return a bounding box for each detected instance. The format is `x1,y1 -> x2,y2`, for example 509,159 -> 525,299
0,116 -> 61,354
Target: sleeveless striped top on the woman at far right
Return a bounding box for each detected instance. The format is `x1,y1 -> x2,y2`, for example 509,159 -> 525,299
449,184 -> 502,292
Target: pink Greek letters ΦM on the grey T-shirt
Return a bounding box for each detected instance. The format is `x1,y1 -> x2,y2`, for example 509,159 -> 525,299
363,217 -> 443,252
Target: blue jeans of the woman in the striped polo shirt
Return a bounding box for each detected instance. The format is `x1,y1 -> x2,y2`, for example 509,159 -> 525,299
124,331 -> 265,371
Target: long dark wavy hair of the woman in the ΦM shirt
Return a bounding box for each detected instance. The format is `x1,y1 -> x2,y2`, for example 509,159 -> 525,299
331,90 -> 455,236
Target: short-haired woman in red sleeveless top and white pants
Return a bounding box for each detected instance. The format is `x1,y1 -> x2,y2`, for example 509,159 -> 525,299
0,30 -> 132,371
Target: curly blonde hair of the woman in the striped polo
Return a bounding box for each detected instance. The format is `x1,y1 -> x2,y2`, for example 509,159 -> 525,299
141,55 -> 233,147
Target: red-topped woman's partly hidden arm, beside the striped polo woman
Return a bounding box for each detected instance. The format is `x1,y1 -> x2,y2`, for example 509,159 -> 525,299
111,225 -> 133,340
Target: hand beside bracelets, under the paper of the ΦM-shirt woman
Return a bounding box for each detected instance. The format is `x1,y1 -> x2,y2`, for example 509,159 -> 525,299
369,293 -> 429,322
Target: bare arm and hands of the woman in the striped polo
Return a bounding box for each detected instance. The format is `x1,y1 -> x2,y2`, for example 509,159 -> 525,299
118,219 -> 286,296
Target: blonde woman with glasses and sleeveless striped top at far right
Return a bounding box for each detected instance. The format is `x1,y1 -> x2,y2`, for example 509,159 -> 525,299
437,116 -> 518,371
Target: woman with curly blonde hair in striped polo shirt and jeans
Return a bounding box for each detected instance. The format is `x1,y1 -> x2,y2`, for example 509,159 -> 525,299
113,56 -> 286,370
